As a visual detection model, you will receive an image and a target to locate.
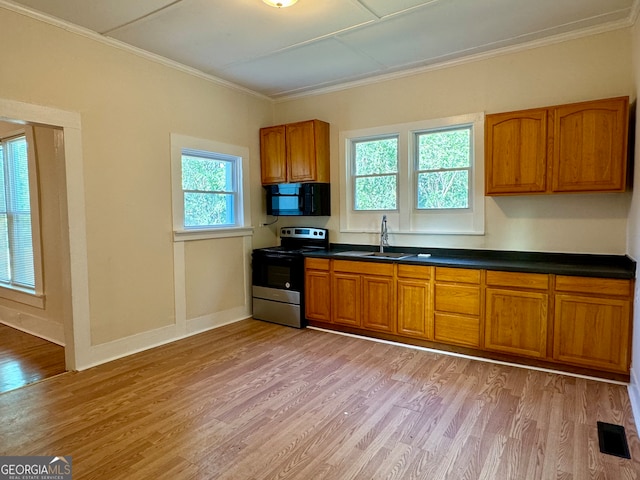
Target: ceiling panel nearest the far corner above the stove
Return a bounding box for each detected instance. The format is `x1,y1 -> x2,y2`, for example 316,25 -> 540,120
222,38 -> 381,96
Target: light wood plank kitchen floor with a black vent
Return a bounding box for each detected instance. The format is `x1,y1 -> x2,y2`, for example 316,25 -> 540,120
0,320 -> 640,480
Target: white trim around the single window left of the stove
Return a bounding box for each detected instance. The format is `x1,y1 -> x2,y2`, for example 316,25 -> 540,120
171,133 -> 253,242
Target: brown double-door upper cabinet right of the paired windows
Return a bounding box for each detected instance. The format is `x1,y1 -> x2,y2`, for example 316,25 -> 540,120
485,97 -> 629,195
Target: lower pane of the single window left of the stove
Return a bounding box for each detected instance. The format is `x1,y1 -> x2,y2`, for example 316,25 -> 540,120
184,192 -> 234,227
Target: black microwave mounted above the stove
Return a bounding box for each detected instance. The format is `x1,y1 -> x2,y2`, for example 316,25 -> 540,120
264,183 -> 331,216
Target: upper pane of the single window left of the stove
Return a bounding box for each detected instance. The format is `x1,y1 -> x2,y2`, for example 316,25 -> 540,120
182,155 -> 233,192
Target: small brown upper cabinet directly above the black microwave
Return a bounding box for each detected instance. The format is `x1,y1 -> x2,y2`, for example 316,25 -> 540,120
260,120 -> 330,185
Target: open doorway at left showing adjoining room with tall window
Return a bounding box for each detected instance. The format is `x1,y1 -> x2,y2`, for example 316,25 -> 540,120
0,119 -> 72,393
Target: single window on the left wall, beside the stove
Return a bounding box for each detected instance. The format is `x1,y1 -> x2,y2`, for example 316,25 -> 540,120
182,149 -> 238,228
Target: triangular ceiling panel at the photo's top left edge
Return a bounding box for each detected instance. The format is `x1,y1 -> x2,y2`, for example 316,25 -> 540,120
11,0 -> 174,33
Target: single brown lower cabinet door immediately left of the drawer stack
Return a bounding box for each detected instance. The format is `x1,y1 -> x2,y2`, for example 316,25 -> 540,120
397,278 -> 433,340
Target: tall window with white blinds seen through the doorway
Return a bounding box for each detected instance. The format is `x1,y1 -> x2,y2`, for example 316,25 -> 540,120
0,132 -> 39,293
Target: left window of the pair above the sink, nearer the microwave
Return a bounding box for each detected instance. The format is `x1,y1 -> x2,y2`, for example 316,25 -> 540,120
352,136 -> 398,210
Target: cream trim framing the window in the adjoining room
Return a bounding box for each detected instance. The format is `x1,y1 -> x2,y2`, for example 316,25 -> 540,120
0,125 -> 45,309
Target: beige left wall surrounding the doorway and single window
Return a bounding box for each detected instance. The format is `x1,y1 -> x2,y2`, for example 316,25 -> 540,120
0,8 -> 273,366
